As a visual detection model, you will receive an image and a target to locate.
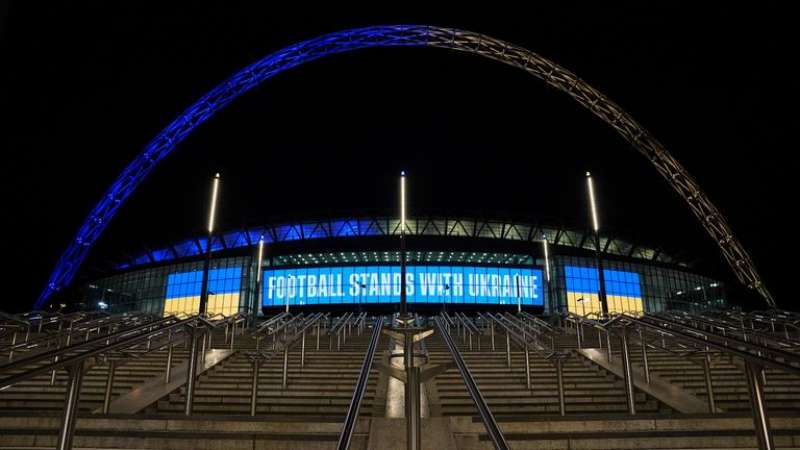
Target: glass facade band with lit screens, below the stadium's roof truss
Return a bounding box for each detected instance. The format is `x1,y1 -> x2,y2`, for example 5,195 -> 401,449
85,251 -> 726,316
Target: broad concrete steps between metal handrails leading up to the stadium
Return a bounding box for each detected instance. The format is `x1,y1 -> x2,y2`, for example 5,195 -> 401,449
0,318 -> 800,450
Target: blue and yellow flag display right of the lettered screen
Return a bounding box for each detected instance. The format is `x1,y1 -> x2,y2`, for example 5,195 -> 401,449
564,266 -> 644,316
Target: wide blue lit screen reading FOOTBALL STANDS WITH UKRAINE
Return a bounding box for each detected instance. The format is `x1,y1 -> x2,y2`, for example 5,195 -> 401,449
262,266 -> 543,306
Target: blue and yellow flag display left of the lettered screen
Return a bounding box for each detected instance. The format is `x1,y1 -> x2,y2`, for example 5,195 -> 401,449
164,267 -> 242,317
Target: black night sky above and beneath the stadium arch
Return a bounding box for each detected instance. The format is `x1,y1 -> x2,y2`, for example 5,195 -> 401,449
0,1 -> 800,309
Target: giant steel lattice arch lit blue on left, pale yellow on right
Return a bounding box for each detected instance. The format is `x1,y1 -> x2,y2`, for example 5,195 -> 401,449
36,25 -> 775,308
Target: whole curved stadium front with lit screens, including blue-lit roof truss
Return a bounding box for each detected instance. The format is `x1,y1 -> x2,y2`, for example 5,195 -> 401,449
84,217 -> 726,315
